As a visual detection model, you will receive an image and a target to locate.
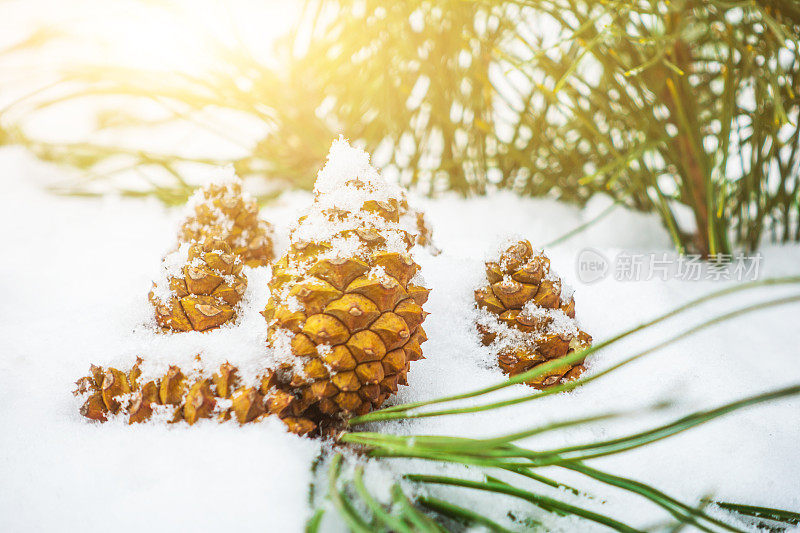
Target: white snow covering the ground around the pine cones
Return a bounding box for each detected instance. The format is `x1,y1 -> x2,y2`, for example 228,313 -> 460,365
0,148 -> 800,532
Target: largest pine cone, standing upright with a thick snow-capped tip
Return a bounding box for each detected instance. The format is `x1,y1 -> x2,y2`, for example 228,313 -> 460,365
263,139 -> 429,432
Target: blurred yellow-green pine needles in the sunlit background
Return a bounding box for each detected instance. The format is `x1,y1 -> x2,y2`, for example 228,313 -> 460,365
0,0 -> 800,256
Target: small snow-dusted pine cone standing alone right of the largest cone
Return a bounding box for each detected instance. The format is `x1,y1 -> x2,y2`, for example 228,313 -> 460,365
475,241 -> 592,389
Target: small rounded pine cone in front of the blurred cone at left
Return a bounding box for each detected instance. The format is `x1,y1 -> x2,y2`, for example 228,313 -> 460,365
149,237 -> 247,331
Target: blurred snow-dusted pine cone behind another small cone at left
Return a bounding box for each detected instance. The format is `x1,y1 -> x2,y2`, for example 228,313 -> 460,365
178,177 -> 275,266
